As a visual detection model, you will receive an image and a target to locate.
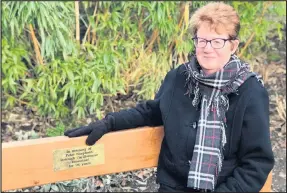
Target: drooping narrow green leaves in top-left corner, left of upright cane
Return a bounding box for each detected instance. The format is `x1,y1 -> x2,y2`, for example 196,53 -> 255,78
2,1 -> 75,61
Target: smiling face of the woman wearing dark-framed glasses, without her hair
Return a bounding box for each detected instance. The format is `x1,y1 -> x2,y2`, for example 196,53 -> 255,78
196,23 -> 239,75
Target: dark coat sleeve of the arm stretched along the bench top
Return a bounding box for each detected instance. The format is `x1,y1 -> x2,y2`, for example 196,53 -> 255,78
106,71 -> 172,131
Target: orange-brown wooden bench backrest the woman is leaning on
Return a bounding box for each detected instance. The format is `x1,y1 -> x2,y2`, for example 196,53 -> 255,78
2,127 -> 272,192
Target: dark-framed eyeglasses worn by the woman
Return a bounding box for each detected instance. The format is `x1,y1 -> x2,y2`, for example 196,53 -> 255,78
192,37 -> 236,49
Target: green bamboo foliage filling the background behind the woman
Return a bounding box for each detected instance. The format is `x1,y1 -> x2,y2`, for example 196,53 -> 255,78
1,1 -> 286,135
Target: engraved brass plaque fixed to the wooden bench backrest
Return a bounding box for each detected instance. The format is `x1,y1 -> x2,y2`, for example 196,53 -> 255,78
53,144 -> 105,171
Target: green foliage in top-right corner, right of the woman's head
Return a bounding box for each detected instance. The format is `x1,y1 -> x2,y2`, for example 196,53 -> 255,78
233,1 -> 286,59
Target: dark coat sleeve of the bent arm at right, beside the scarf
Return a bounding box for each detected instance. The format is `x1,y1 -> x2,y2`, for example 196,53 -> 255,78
215,86 -> 274,192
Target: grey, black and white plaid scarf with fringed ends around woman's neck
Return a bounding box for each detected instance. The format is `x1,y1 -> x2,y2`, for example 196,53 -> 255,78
185,55 -> 262,191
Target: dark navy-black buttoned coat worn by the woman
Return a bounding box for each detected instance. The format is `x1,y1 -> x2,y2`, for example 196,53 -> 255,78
108,65 -> 274,192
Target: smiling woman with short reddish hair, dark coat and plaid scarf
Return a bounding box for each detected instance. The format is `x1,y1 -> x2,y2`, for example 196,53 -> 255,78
65,2 -> 274,192
